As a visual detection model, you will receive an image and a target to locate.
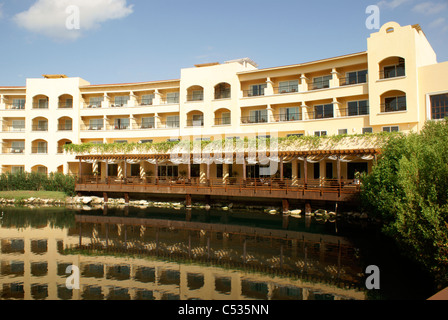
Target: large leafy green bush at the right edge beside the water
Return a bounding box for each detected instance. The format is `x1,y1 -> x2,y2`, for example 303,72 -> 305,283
361,120 -> 448,286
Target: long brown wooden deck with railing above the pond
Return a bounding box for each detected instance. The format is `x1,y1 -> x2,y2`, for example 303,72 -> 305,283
76,177 -> 360,202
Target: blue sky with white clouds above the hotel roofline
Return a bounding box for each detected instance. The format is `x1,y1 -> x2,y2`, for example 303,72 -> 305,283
0,0 -> 448,86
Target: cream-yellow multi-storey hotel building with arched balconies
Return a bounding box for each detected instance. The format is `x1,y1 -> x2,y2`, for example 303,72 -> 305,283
0,22 -> 448,185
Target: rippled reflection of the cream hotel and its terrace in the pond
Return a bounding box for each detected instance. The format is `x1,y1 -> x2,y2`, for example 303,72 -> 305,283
0,217 -> 365,300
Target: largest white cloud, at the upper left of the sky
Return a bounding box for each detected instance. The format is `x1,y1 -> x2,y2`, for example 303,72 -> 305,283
14,0 -> 133,40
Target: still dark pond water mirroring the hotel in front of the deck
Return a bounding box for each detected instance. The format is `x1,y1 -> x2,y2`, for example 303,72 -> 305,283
0,207 -> 434,300
